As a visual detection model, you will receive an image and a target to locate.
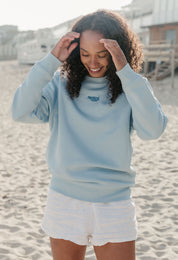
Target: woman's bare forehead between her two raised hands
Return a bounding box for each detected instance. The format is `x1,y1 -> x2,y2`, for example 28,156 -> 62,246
80,30 -> 105,51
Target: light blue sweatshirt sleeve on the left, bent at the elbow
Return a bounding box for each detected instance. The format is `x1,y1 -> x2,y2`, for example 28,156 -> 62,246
11,53 -> 61,123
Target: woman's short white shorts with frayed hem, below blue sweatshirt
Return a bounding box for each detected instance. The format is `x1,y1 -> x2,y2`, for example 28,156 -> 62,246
41,189 -> 137,246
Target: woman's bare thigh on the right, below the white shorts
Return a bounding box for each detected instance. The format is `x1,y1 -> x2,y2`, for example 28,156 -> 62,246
94,241 -> 135,260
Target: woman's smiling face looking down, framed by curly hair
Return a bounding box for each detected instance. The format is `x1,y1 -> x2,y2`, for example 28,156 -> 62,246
80,30 -> 109,78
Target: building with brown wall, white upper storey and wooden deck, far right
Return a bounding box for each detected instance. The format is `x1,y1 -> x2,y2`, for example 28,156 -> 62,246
144,0 -> 178,85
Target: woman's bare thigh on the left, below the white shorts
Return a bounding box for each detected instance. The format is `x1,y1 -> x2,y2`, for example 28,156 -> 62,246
50,238 -> 86,260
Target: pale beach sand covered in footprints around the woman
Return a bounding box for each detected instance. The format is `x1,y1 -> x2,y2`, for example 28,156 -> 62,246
0,61 -> 178,260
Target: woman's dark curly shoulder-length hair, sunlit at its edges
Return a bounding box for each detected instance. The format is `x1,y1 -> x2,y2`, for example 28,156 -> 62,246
60,10 -> 143,103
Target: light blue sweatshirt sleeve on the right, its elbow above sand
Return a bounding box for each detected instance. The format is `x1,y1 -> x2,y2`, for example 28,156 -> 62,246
116,64 -> 168,140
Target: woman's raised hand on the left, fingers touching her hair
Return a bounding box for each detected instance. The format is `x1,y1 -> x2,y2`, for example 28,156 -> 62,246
51,32 -> 80,62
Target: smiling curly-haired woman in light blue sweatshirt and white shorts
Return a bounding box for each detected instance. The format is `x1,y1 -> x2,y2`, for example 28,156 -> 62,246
12,10 -> 167,260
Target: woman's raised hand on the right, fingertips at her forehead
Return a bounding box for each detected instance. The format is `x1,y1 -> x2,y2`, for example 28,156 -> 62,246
100,39 -> 127,71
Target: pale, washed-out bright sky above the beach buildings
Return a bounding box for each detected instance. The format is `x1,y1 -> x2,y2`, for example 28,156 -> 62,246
0,0 -> 132,31
